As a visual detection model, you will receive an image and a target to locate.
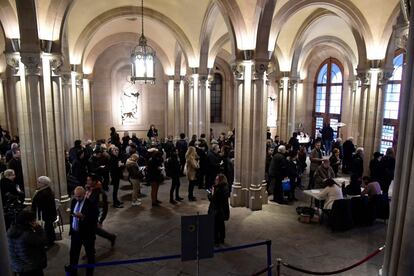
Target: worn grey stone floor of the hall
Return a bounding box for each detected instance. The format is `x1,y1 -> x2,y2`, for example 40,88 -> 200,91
46,178 -> 386,276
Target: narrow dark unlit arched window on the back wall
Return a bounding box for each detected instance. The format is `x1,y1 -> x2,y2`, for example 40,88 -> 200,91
210,73 -> 223,123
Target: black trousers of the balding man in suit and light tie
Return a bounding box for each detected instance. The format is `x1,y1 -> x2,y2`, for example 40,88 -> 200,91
69,232 -> 95,276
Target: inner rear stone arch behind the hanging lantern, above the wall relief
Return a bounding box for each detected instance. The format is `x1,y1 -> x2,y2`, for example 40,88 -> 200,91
82,33 -> 173,75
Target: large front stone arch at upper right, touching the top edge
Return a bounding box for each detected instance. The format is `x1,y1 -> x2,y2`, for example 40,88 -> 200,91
269,0 -> 373,67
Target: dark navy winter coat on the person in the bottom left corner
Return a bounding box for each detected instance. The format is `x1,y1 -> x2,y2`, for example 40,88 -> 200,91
7,225 -> 47,272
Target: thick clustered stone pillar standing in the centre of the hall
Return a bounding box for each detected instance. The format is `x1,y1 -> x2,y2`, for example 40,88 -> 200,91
231,56 -> 267,210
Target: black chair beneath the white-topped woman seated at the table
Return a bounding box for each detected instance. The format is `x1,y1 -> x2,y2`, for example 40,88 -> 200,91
329,199 -> 354,231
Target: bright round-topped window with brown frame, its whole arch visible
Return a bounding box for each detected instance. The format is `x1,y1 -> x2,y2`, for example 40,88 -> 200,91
313,58 -> 343,138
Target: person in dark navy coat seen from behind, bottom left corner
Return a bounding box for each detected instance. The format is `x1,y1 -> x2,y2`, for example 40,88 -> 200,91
7,211 -> 47,276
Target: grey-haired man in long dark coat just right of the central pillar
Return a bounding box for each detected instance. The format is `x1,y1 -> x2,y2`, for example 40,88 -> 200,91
269,145 -> 287,204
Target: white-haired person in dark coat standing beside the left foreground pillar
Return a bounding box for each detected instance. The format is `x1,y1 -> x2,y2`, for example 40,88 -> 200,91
32,176 -> 57,247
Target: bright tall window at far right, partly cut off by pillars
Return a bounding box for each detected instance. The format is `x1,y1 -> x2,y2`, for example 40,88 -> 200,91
381,51 -> 405,153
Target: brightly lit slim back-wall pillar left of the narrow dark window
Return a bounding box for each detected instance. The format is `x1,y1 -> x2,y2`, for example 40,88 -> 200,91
187,68 -> 200,137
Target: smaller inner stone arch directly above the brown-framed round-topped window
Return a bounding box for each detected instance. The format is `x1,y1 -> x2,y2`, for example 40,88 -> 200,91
292,36 -> 357,78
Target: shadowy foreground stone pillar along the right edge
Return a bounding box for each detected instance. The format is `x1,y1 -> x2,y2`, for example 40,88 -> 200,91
382,5 -> 414,275
